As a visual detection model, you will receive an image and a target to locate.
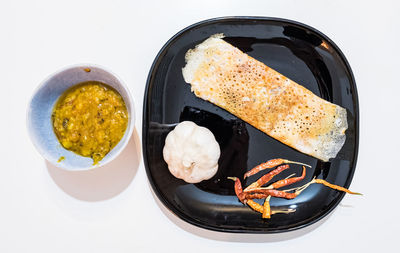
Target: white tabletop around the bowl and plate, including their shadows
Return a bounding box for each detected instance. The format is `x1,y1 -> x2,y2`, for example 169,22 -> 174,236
0,0 -> 400,253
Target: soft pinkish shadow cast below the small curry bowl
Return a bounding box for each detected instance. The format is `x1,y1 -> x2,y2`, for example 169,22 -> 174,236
46,128 -> 142,202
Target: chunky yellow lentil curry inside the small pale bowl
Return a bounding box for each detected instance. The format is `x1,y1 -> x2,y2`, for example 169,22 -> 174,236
52,81 -> 128,164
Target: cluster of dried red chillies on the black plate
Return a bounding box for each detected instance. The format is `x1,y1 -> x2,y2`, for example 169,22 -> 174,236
228,159 -> 362,219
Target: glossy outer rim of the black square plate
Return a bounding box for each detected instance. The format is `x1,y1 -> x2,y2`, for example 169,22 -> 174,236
142,16 -> 360,234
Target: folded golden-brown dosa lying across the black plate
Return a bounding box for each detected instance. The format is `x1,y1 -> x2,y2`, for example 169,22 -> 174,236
182,34 -> 347,161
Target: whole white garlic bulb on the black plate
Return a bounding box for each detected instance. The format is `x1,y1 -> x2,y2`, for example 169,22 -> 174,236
163,121 -> 221,183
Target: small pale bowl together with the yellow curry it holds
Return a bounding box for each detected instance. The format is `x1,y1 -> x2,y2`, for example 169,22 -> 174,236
27,65 -> 134,170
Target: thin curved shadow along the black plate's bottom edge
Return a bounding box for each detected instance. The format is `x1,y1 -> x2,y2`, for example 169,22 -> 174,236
149,185 -> 335,243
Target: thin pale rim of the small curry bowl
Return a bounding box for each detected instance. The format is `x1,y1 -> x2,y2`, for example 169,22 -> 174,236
25,63 -> 136,171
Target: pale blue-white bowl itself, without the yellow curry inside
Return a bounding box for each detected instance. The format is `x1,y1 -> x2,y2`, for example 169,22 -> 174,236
27,64 -> 135,170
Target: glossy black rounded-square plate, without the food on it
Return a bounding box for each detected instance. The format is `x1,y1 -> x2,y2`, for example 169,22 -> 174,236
143,17 -> 359,233
